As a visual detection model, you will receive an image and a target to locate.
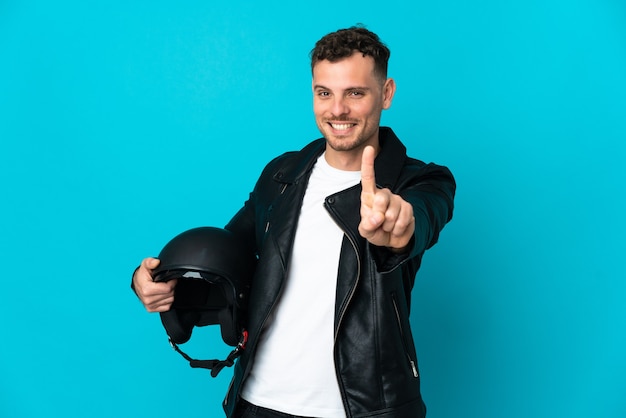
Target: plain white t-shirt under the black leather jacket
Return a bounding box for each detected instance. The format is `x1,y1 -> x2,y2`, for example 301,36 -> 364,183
242,155 -> 361,418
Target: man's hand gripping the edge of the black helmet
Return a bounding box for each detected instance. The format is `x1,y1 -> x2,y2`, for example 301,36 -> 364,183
133,257 -> 177,312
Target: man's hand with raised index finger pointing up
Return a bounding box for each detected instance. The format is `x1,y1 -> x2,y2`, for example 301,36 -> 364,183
359,146 -> 415,252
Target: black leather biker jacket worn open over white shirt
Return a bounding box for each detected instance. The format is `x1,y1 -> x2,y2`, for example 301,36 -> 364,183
223,128 -> 455,418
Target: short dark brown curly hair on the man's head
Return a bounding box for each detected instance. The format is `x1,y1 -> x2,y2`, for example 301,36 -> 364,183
310,25 -> 391,80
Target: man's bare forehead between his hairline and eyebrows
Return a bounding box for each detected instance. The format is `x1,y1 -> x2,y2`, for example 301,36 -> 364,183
313,52 -> 377,88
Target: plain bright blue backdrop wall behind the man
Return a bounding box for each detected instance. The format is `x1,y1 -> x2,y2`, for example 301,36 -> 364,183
0,0 -> 626,418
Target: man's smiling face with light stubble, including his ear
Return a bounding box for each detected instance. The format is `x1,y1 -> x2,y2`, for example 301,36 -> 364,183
313,52 -> 395,153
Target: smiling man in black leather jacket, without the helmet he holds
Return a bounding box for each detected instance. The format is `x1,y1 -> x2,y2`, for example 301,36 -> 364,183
133,27 -> 455,418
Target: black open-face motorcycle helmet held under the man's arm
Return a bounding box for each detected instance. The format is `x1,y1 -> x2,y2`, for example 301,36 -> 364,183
153,227 -> 256,376
